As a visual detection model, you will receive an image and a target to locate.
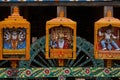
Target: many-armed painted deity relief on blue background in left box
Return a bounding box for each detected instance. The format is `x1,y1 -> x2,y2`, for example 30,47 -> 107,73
4,29 -> 26,49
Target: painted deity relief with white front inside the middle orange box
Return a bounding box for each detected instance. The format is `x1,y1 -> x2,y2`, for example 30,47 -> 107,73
49,28 -> 73,49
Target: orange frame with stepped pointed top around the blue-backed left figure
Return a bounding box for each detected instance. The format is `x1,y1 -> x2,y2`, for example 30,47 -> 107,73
0,7 -> 30,60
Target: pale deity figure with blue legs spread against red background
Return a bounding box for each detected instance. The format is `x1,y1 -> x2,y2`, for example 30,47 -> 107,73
98,29 -> 120,50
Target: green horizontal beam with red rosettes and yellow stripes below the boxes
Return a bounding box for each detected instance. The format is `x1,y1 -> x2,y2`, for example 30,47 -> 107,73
0,67 -> 120,78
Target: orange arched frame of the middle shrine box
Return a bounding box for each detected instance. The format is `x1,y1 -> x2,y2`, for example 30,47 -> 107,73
46,17 -> 76,59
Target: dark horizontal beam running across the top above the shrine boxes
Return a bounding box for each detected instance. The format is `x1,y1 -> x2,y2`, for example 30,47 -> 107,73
0,1 -> 120,7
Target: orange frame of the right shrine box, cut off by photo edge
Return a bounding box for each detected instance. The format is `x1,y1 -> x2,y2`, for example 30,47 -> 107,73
94,17 -> 120,59
